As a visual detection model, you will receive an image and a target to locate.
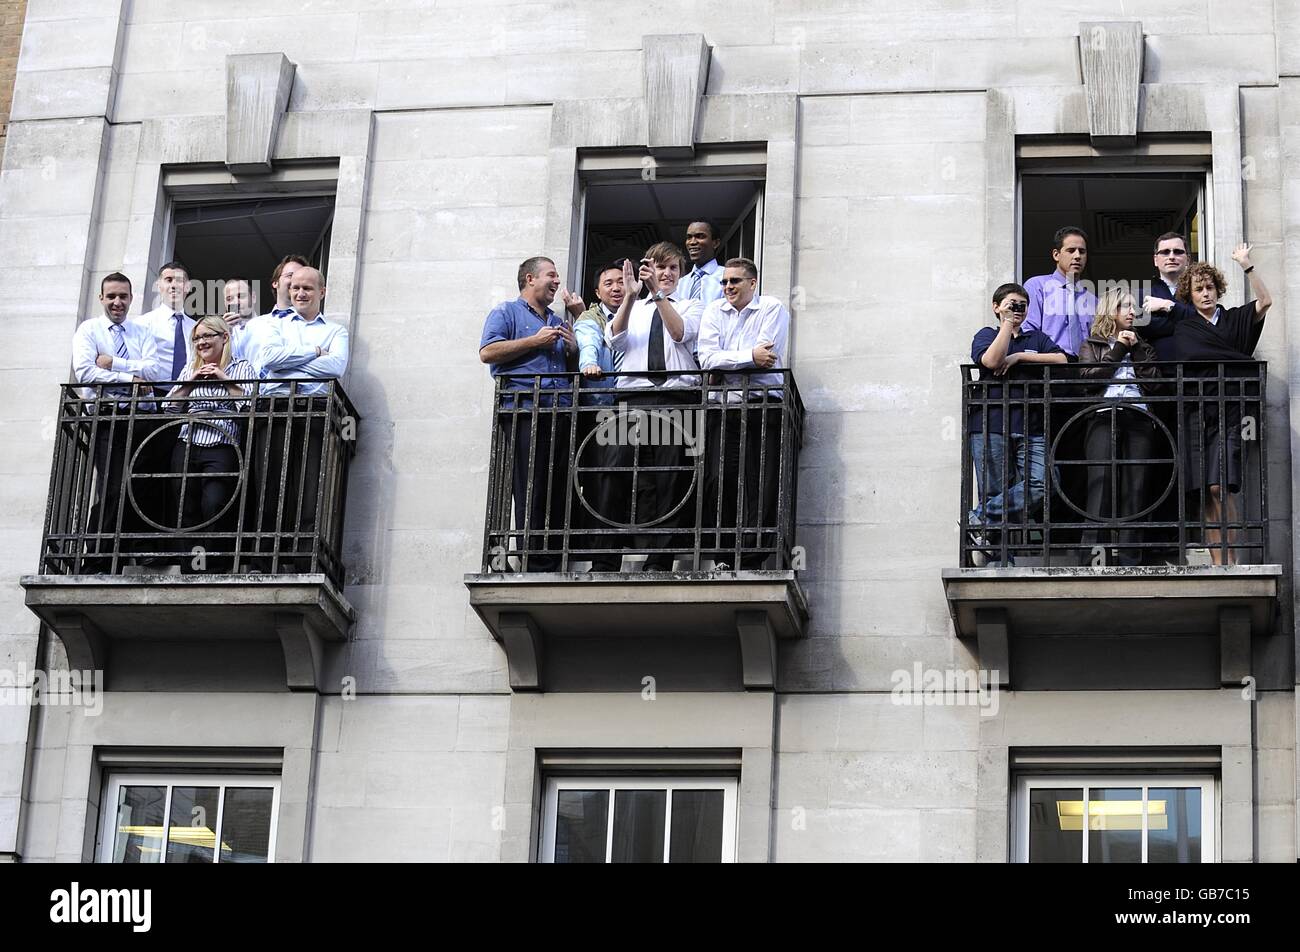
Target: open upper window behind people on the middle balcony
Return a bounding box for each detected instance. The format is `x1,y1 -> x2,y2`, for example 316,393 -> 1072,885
576,150 -> 766,294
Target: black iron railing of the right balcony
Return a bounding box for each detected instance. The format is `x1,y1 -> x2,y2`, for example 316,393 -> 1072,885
961,360 -> 1269,567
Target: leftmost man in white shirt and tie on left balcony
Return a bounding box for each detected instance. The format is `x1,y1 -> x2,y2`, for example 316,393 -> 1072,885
73,272 -> 157,571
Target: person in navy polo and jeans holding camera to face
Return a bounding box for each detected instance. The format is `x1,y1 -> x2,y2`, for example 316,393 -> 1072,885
967,284 -> 1069,556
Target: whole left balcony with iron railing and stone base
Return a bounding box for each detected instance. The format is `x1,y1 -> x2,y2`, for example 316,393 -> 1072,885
20,381 -> 358,689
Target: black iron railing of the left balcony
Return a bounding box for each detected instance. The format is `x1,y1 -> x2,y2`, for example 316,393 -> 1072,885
40,380 -> 359,585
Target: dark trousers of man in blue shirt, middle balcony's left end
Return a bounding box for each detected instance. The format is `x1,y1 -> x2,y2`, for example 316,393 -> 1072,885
501,407 -> 571,572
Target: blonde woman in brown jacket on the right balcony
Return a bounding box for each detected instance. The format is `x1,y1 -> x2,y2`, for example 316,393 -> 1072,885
1079,289 -> 1160,566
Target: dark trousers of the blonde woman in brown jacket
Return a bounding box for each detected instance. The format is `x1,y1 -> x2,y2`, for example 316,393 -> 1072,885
1080,410 -> 1154,566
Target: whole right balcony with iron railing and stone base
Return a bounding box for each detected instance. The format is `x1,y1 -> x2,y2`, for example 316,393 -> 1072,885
943,362 -> 1282,687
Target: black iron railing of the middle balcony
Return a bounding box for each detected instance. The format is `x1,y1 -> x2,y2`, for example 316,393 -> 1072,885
482,371 -> 803,572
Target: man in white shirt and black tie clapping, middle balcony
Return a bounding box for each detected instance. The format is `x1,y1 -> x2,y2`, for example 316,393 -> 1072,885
601,242 -> 702,572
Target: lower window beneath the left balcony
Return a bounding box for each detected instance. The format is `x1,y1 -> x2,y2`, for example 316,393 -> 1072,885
98,774 -> 280,862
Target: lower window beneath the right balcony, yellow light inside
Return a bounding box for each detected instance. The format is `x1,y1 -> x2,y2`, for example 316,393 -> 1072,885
1017,775 -> 1216,862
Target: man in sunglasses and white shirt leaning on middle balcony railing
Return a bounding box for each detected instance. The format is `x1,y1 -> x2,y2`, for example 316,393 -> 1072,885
697,258 -> 790,568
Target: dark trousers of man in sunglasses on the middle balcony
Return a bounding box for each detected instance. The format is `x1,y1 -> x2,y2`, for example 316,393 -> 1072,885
702,404 -> 781,568
